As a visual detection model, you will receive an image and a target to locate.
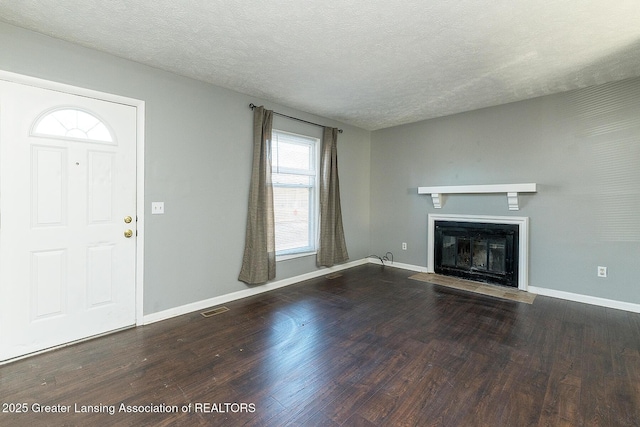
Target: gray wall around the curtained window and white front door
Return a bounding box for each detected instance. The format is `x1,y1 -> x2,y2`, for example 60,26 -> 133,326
0,23 -> 370,314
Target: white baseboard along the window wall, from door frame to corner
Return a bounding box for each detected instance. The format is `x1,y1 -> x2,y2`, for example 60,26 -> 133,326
142,259 -> 369,325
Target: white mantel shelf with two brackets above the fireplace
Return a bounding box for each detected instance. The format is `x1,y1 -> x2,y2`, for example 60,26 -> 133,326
418,183 -> 537,211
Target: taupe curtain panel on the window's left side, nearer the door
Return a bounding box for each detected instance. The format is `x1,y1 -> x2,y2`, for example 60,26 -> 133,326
238,106 -> 276,285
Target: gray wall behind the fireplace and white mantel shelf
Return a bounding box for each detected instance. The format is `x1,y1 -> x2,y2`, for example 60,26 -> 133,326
371,79 -> 640,303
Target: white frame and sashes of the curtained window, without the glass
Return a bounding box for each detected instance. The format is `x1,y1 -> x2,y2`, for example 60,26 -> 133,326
271,128 -> 321,261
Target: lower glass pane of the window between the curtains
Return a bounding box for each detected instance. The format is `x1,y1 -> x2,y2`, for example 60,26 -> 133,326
273,187 -> 313,252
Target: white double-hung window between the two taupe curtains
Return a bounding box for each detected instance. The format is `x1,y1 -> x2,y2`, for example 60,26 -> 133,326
271,130 -> 320,255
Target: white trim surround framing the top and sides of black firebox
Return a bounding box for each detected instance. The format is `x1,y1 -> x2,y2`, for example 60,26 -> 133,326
427,214 -> 529,291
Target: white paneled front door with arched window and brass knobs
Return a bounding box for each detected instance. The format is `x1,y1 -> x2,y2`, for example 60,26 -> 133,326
0,81 -> 136,361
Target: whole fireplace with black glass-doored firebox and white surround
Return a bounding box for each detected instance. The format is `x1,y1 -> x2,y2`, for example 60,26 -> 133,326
427,214 -> 529,291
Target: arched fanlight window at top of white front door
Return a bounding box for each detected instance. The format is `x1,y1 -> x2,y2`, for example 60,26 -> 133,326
31,107 -> 115,143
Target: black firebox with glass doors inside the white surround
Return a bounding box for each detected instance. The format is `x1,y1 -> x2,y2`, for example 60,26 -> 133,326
434,221 -> 519,287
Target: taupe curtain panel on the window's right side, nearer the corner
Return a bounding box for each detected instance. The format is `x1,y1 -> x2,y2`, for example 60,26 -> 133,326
316,127 -> 349,267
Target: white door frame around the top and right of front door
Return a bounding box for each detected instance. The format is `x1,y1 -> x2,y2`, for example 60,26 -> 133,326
0,70 -> 145,326
